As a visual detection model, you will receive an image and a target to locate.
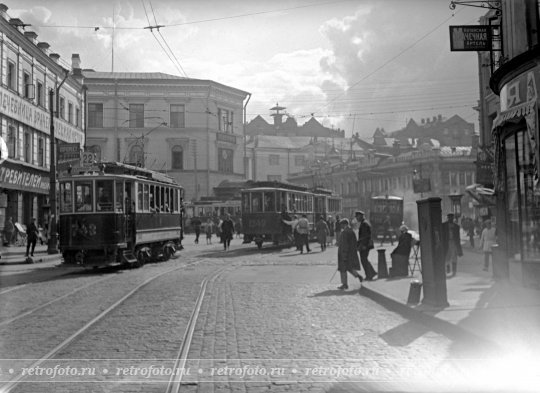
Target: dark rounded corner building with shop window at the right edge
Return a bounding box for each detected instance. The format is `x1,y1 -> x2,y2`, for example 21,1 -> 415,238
490,0 -> 540,287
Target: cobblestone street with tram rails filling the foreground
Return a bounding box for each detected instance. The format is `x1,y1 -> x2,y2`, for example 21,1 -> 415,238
0,237 -> 510,392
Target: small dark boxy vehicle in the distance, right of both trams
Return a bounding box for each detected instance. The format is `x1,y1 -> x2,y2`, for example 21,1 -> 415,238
369,195 -> 403,238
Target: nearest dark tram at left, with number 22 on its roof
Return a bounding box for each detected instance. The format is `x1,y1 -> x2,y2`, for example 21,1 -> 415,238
58,162 -> 184,267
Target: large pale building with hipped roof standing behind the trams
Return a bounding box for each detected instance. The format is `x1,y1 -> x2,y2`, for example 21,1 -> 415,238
83,70 -> 249,200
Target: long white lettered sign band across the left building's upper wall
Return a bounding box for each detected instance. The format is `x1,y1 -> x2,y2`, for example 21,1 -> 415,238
0,86 -> 84,144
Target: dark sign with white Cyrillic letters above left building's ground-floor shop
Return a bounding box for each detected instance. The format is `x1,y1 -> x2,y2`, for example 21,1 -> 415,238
0,161 -> 50,194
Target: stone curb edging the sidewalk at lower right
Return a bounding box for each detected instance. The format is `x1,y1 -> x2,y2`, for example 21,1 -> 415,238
360,285 -> 503,351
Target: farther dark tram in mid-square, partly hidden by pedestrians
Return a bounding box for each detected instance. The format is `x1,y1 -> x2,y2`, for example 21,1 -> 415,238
241,181 -> 341,249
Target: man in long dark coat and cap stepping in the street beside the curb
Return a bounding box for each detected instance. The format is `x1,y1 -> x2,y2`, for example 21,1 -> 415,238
338,218 -> 363,290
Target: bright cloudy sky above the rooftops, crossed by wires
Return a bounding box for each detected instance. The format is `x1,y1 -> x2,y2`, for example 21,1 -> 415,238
10,0 -> 487,138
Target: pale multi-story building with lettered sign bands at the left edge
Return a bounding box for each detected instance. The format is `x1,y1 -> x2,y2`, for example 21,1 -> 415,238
0,4 -> 84,228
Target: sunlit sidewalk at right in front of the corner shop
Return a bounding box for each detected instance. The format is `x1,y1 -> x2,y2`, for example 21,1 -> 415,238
361,241 -> 540,356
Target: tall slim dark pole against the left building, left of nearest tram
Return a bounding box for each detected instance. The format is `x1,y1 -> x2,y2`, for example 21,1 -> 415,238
47,70 -> 69,254
